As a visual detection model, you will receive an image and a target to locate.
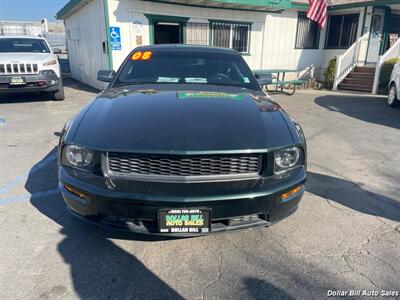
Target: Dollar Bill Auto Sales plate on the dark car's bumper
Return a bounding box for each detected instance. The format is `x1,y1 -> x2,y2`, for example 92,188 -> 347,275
158,208 -> 211,234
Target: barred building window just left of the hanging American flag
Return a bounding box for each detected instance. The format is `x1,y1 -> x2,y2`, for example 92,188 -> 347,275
296,12 -> 320,49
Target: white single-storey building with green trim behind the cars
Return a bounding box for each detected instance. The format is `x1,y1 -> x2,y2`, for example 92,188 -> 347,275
57,0 -> 400,92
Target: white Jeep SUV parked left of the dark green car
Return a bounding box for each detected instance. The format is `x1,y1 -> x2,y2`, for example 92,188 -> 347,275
0,36 -> 64,100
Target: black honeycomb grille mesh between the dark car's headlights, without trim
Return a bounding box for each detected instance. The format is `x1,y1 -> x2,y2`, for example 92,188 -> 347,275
108,152 -> 262,177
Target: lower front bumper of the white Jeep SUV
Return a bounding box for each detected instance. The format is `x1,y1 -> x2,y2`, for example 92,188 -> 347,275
0,71 -> 60,93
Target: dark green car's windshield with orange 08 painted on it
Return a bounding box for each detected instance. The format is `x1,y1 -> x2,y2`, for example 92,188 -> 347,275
114,49 -> 259,90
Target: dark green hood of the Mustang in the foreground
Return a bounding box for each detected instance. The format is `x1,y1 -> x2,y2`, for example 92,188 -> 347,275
72,89 -> 293,153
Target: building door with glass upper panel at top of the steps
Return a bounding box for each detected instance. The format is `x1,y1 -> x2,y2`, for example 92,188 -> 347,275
367,8 -> 385,63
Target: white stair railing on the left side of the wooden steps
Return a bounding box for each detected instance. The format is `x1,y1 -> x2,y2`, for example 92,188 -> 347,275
333,37 -> 362,91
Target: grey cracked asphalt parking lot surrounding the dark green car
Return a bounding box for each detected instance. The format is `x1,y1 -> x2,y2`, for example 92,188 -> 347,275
0,78 -> 400,299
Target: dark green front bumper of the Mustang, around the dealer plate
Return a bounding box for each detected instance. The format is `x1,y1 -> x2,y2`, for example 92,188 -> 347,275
59,166 -> 306,236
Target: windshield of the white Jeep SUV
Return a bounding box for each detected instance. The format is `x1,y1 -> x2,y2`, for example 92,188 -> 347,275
0,38 -> 50,53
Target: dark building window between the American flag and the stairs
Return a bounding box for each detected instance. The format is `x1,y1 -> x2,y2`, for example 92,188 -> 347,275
325,14 -> 359,49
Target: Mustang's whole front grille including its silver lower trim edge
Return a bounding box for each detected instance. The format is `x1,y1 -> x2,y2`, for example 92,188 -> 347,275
102,152 -> 263,182
